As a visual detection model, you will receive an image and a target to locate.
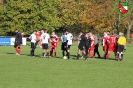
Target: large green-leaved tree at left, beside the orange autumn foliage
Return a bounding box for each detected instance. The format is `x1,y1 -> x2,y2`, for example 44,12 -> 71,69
0,0 -> 61,35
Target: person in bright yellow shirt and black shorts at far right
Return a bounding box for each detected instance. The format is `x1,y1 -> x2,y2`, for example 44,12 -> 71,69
116,32 -> 126,61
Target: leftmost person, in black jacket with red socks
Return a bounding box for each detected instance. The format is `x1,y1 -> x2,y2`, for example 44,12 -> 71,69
14,30 -> 22,55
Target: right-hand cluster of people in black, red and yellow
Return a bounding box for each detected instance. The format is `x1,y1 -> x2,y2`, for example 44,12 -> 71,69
76,32 -> 126,61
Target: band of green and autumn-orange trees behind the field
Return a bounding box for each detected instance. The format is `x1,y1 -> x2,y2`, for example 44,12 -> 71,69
0,0 -> 133,38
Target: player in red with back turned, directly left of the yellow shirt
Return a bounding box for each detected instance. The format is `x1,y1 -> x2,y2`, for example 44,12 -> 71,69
106,33 -> 117,59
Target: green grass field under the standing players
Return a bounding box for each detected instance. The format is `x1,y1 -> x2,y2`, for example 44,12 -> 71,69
0,45 -> 133,88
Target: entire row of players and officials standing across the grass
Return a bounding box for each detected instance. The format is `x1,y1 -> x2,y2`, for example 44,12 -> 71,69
15,30 -> 126,61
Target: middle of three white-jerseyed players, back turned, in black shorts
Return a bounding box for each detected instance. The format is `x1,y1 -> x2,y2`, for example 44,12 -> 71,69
40,30 -> 50,57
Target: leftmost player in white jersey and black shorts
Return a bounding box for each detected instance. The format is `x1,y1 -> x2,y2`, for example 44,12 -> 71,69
29,30 -> 37,56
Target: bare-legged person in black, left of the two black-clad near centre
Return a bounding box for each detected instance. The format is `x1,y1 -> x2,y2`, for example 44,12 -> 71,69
75,32 -> 86,60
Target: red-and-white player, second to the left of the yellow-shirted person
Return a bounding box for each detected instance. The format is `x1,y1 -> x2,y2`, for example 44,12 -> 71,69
102,32 -> 109,59
